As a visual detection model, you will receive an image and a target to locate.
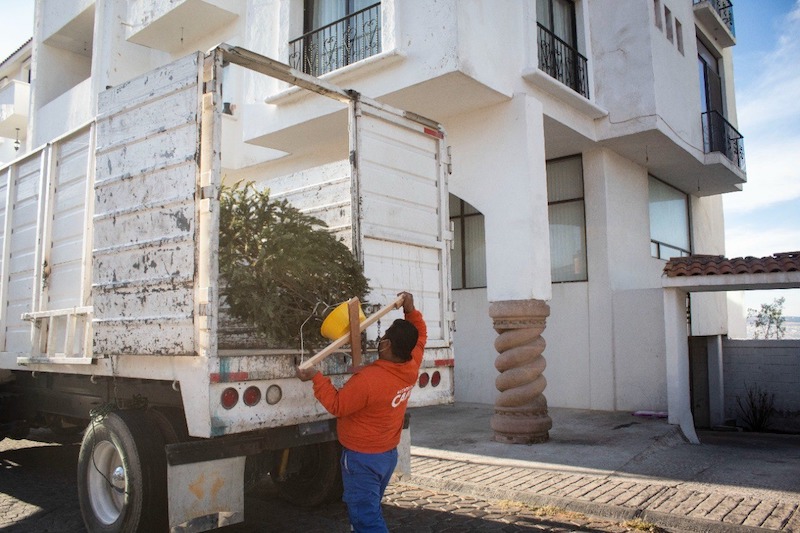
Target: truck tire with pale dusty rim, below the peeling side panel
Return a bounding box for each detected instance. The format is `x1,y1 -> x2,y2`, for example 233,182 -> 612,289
78,410 -> 168,533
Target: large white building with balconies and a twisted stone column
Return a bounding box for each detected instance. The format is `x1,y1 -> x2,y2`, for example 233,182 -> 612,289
20,0 -> 746,442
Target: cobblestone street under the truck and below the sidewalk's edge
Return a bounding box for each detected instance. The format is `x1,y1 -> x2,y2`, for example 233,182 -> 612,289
0,430 -> 652,533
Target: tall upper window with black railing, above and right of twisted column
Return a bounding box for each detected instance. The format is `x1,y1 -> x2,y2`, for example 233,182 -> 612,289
536,0 -> 589,98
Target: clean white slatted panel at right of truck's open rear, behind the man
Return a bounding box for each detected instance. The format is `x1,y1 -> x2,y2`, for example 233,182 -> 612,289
356,105 -> 450,347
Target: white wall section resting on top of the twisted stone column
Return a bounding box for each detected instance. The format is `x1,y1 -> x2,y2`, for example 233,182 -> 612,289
445,94 -> 551,301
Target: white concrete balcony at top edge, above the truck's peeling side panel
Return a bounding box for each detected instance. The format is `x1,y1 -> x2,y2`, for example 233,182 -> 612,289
126,0 -> 244,52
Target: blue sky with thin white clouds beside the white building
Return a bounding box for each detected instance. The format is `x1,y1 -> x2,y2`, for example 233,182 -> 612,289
0,0 -> 800,316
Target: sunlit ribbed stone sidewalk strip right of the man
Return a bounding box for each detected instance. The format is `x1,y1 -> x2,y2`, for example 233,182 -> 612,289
408,455 -> 800,532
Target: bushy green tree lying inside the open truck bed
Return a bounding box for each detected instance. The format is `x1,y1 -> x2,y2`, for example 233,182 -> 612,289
219,182 -> 369,347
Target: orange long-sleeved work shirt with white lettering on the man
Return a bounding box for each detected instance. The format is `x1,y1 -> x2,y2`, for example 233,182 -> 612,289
313,309 -> 428,453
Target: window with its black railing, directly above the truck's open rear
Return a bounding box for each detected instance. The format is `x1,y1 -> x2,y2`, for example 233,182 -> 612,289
289,0 -> 381,76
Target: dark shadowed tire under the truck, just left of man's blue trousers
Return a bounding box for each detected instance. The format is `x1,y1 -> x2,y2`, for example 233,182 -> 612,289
270,441 -> 342,507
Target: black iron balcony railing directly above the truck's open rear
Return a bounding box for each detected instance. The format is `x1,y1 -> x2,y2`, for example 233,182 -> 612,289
289,2 -> 381,76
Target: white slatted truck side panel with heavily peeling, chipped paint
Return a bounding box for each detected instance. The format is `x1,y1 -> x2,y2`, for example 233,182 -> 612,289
92,55 -> 202,355
